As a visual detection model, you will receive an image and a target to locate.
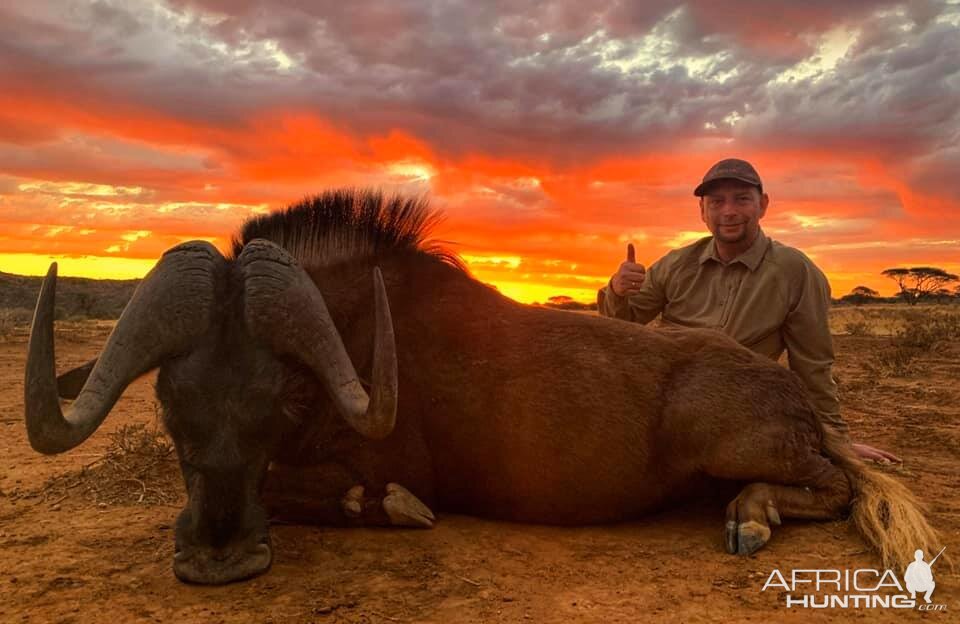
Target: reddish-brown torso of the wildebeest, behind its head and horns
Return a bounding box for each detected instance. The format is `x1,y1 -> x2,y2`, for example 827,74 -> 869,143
266,255 -> 820,524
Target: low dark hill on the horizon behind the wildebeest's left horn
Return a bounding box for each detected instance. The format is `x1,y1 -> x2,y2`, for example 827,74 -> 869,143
0,271 -> 140,320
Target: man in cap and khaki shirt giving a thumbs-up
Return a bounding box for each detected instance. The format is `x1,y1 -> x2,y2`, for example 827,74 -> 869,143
597,158 -> 900,462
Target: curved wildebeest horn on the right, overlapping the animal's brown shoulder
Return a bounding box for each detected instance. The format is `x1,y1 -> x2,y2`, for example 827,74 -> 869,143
239,239 -> 397,439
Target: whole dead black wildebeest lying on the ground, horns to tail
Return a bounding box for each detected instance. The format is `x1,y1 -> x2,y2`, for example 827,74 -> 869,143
26,192 -> 936,583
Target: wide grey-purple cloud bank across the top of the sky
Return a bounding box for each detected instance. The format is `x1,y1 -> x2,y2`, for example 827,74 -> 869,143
0,0 -> 960,190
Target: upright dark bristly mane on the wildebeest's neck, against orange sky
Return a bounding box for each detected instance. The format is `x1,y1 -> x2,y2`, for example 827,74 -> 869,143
232,189 -> 465,270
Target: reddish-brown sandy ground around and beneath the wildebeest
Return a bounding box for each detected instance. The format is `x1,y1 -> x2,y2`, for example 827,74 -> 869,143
0,323 -> 960,623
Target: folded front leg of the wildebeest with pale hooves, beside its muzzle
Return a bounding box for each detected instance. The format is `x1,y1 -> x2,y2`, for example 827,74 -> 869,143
262,462 -> 434,528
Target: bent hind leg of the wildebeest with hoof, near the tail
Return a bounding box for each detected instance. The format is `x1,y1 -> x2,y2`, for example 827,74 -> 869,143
705,424 -> 851,555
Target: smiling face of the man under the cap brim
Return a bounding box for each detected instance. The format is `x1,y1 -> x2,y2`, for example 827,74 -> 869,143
700,180 -> 770,244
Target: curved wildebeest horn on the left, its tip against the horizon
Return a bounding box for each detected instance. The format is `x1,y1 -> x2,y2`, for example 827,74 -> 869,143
24,241 -> 225,454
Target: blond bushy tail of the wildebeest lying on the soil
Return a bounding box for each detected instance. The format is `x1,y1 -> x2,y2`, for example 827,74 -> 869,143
823,425 -> 953,571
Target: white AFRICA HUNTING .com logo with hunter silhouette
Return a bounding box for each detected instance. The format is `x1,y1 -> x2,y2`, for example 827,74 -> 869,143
760,546 -> 947,611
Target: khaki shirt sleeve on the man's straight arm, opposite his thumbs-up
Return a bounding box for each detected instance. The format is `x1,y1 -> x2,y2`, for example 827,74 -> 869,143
783,260 -> 849,436
